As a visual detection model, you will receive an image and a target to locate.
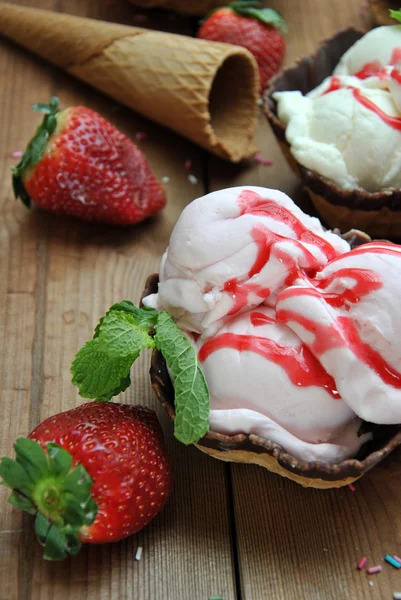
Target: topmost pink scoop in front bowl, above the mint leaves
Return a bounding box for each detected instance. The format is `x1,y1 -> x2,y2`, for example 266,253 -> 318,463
144,187 -> 349,336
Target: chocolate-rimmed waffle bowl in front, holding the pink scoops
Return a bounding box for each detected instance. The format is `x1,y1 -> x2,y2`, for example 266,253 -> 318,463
143,230 -> 401,489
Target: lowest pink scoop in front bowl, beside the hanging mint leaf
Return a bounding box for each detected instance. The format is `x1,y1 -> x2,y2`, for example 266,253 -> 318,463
196,307 -> 365,462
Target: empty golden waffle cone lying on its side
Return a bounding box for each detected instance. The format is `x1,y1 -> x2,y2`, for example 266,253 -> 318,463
0,2 -> 259,162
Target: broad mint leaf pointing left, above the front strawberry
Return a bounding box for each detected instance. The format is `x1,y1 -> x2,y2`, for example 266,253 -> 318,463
71,308 -> 154,401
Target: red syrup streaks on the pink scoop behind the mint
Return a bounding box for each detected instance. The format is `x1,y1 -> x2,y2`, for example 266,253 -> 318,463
223,190 -> 336,315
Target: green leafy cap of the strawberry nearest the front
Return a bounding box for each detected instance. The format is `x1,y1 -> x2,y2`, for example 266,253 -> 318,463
0,438 -> 97,560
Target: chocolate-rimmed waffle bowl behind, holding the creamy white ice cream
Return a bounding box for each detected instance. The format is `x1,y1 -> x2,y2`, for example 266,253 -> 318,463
264,29 -> 401,239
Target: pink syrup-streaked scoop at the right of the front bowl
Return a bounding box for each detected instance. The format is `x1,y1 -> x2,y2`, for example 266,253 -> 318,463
276,242 -> 401,424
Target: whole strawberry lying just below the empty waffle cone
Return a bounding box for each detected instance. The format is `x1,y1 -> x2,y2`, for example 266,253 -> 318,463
13,98 -> 166,225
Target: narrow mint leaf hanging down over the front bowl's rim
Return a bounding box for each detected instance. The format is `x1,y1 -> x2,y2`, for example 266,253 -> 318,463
155,310 -> 210,444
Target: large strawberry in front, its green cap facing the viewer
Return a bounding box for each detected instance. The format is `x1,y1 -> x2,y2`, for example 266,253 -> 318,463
0,402 -> 173,560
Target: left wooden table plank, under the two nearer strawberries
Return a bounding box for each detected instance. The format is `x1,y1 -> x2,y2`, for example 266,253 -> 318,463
0,0 -> 236,600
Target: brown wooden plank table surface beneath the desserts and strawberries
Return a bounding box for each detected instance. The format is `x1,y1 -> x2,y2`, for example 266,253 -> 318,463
0,0 -> 401,600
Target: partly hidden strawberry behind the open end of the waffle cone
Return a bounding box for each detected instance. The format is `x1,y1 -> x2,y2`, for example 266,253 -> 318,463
198,0 -> 286,92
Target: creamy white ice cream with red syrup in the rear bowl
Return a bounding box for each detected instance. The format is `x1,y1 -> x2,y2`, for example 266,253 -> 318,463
273,26 -> 401,192
